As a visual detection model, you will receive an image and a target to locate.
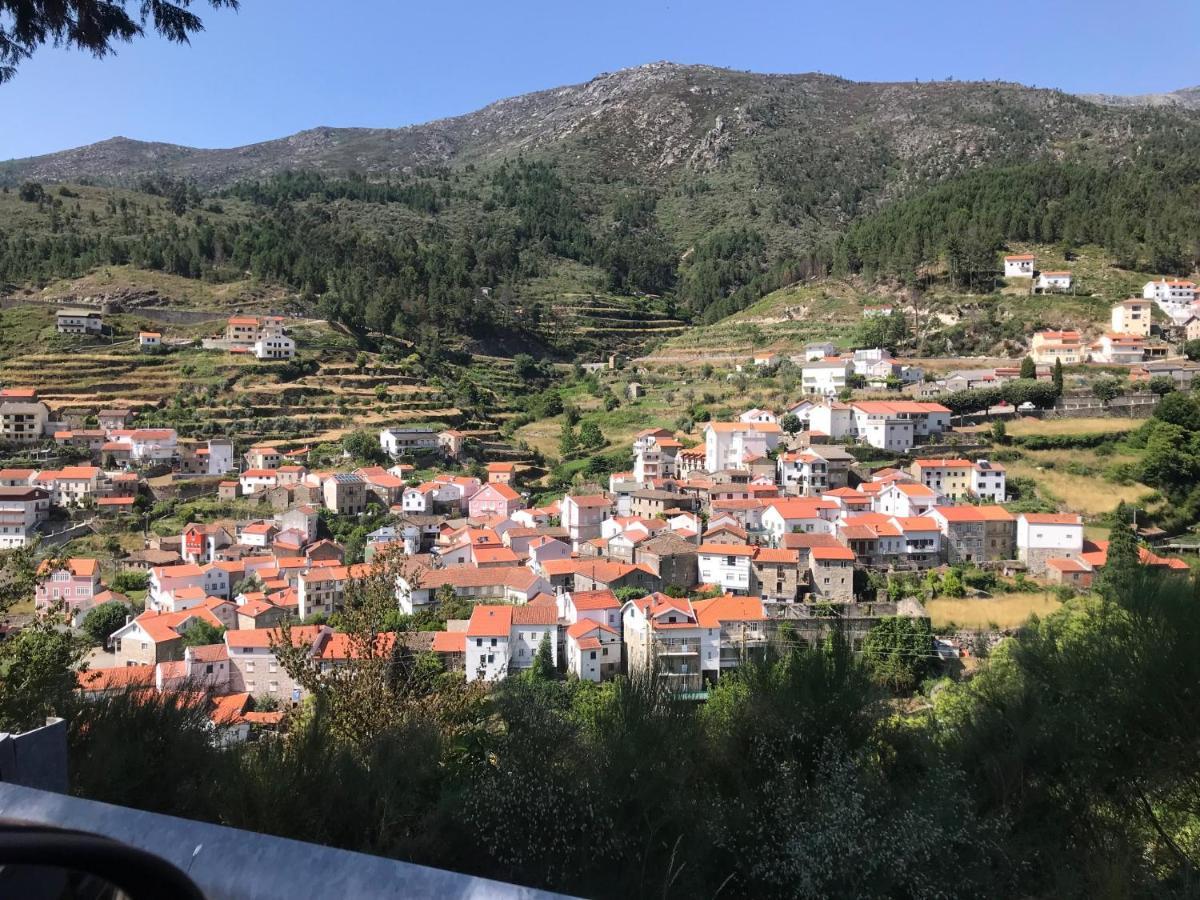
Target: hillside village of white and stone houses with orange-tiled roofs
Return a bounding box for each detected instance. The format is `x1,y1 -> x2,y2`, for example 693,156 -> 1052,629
0,264 -> 1200,740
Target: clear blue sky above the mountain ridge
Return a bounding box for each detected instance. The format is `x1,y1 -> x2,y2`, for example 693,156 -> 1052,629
0,0 -> 1200,160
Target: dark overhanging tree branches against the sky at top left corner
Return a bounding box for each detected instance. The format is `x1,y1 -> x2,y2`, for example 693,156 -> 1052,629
0,0 -> 239,84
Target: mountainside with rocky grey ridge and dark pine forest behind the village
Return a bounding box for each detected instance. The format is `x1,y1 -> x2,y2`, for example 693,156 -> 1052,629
0,64 -> 1200,355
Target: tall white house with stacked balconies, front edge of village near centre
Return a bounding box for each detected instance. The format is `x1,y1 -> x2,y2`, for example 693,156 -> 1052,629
622,594 -> 703,692
